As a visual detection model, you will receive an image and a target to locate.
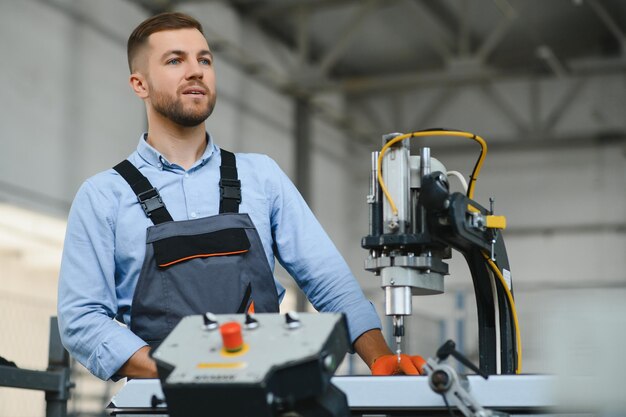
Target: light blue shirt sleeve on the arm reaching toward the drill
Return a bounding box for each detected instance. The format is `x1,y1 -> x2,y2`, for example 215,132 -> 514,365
268,158 -> 381,343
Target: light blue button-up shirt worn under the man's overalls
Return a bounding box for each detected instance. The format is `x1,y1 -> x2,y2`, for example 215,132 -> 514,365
58,136 -> 381,380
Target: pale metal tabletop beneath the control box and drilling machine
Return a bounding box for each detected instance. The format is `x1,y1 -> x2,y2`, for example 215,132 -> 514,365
108,375 -> 556,417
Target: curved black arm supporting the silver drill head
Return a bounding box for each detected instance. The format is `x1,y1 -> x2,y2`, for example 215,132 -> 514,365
420,172 -> 517,374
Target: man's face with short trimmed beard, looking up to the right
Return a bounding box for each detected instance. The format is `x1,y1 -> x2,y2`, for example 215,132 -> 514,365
138,29 -> 217,127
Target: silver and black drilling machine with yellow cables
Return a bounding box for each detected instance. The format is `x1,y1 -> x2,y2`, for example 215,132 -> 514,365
361,129 -> 521,375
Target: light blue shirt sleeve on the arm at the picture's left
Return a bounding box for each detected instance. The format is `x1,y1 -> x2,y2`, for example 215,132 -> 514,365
58,181 -> 146,380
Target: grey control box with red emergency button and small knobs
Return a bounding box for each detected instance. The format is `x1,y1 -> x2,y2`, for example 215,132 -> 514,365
152,313 -> 349,417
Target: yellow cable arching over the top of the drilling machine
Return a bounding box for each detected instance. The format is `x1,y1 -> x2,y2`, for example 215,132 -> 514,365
377,130 -> 487,216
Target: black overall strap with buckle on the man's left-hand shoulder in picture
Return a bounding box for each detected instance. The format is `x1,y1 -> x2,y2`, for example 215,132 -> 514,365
113,159 -> 172,224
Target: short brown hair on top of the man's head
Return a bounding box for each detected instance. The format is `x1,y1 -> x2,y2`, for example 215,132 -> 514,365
126,12 -> 204,73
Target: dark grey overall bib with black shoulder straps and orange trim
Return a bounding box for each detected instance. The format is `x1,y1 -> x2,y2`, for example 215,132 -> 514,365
114,149 -> 278,348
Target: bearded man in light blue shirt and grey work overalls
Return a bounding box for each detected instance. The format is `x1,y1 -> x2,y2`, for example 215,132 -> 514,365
58,13 -> 417,379
